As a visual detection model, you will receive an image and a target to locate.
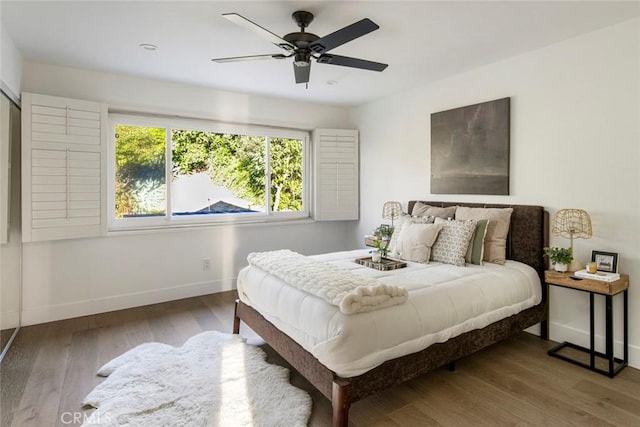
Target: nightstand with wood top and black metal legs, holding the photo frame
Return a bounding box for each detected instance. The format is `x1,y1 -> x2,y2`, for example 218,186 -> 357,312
544,270 -> 629,378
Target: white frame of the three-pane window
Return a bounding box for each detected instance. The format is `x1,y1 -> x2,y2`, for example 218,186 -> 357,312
107,112 -> 312,231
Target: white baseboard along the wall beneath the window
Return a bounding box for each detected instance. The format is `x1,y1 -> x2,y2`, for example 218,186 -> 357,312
21,278 -> 236,326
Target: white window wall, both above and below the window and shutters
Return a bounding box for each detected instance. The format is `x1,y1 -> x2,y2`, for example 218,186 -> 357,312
22,61 -> 354,328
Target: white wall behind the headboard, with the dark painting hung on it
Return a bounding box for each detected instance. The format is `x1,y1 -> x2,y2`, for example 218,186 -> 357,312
352,19 -> 640,367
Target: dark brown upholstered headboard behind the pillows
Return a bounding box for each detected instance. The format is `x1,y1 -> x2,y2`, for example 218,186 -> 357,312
407,200 -> 549,279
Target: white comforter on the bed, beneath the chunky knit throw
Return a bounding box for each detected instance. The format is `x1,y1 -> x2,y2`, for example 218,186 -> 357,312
238,250 -> 541,377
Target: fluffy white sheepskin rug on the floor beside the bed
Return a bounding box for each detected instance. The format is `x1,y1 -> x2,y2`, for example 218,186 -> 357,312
82,332 -> 311,427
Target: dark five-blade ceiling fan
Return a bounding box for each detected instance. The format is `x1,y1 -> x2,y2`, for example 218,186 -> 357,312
212,10 -> 388,83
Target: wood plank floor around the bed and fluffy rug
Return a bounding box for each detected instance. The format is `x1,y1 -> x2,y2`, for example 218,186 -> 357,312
0,292 -> 640,427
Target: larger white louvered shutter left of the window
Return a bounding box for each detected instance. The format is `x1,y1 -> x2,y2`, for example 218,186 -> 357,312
22,93 -> 107,242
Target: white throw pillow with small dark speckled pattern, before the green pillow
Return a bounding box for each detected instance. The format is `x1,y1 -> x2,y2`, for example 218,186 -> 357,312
431,218 -> 476,267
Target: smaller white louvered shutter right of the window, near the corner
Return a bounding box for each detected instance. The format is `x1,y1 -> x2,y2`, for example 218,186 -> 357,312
313,129 -> 359,221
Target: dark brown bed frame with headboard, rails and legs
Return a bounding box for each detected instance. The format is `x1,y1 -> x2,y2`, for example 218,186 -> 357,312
233,201 -> 548,427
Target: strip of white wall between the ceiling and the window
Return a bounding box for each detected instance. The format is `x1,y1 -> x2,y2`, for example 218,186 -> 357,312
22,61 -> 348,130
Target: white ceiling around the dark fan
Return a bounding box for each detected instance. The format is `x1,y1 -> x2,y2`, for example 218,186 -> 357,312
0,0 -> 640,106
